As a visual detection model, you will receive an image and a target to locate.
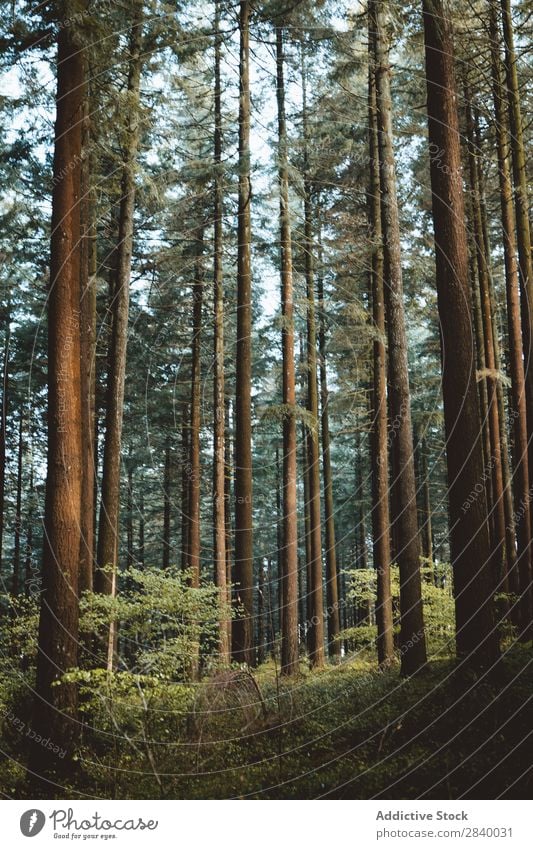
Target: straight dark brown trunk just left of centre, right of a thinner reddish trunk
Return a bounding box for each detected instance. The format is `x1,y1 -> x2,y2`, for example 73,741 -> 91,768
232,0 -> 254,666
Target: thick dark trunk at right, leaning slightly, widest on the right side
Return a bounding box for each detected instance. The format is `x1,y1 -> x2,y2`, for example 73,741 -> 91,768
423,0 -> 498,666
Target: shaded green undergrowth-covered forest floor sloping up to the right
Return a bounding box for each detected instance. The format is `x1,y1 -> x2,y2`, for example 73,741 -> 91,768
0,647 -> 533,799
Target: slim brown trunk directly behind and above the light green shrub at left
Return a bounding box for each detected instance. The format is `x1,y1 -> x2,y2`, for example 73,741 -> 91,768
187,232 -> 204,587
